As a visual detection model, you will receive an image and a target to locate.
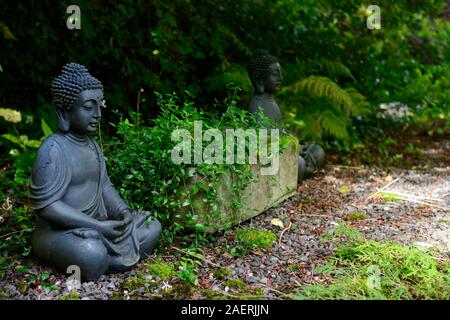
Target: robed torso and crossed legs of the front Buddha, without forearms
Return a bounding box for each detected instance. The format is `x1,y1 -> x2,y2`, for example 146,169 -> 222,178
30,132 -> 161,280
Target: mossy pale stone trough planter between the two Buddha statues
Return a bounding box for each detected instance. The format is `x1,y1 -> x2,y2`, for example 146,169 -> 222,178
174,137 -> 300,233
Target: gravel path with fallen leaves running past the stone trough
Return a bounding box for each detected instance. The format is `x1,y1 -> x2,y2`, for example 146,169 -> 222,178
0,142 -> 450,299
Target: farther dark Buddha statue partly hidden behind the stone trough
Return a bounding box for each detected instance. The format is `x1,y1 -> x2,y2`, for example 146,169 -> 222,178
248,49 -> 325,182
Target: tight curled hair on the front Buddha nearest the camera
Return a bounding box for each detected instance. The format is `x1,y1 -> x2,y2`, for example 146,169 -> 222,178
51,63 -> 103,109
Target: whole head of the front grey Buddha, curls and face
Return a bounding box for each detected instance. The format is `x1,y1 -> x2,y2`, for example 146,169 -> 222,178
51,63 -> 104,136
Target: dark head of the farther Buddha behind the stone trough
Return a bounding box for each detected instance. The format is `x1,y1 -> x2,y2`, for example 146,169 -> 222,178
248,49 -> 283,94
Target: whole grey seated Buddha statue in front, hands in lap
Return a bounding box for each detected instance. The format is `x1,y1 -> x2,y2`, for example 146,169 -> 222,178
30,63 -> 161,281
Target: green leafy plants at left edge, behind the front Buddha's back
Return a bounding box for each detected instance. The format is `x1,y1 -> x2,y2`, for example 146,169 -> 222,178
0,109 -> 51,278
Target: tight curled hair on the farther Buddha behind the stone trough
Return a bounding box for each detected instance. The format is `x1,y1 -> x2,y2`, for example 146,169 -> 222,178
247,49 -> 279,93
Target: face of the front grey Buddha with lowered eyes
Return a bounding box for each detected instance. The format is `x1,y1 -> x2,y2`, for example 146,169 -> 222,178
68,89 -> 103,135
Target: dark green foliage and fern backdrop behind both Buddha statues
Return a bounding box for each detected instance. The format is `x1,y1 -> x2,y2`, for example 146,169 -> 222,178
0,0 -> 450,141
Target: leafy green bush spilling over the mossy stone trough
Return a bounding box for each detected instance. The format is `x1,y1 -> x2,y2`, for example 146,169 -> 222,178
105,95 -> 284,238
